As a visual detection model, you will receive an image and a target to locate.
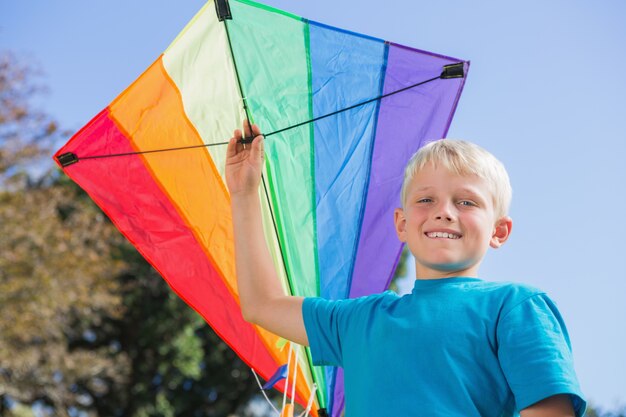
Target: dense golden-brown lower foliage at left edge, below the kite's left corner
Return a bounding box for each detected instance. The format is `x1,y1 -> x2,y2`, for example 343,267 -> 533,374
0,172 -> 128,415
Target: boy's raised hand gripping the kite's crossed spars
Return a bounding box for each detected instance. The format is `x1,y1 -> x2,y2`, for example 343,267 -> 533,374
226,123 -> 265,197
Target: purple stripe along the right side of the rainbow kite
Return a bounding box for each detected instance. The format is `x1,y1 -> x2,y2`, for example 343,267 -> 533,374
332,44 -> 468,417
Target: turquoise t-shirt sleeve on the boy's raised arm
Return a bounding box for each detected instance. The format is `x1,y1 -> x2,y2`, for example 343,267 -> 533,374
302,297 -> 348,366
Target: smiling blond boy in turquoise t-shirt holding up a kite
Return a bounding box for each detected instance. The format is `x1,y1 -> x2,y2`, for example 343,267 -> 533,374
226,126 -> 585,417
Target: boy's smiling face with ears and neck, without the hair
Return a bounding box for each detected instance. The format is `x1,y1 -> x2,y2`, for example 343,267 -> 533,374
395,164 -> 512,278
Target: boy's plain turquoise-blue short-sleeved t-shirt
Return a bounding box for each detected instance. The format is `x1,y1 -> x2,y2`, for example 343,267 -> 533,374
302,278 -> 586,417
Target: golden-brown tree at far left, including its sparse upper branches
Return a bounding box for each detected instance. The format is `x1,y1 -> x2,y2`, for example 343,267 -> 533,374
0,53 -> 123,415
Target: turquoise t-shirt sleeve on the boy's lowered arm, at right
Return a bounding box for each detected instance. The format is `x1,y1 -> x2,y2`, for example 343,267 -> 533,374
498,294 -> 586,416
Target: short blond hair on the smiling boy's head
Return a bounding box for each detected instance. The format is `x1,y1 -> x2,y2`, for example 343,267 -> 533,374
401,139 -> 513,218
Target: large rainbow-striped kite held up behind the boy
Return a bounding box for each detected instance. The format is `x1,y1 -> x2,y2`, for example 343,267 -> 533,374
55,0 -> 469,416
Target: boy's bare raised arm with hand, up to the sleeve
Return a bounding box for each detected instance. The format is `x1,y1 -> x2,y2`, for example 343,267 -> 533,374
226,125 -> 308,345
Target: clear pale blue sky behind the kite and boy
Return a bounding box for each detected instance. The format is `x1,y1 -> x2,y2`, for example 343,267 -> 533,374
0,0 -> 626,408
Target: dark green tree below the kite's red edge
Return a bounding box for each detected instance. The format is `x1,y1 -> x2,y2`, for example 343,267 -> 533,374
88,247 -> 258,417
